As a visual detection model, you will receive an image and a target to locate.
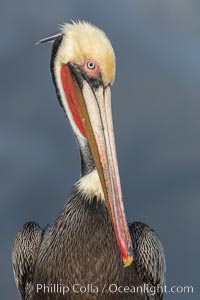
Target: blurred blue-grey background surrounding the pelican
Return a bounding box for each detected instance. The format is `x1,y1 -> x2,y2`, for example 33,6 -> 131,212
0,0 -> 200,300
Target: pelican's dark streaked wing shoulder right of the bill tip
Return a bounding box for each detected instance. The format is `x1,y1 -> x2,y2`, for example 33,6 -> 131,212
129,222 -> 166,300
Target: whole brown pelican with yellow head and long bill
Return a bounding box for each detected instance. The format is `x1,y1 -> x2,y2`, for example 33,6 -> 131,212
12,22 -> 165,300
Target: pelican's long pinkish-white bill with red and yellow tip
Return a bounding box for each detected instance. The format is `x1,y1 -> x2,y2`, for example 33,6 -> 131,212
60,66 -> 133,266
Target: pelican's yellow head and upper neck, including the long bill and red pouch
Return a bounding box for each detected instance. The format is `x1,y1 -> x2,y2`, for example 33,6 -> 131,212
38,22 -> 133,266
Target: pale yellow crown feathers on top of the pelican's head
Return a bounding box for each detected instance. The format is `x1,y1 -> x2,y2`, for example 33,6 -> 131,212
56,22 -> 115,84
